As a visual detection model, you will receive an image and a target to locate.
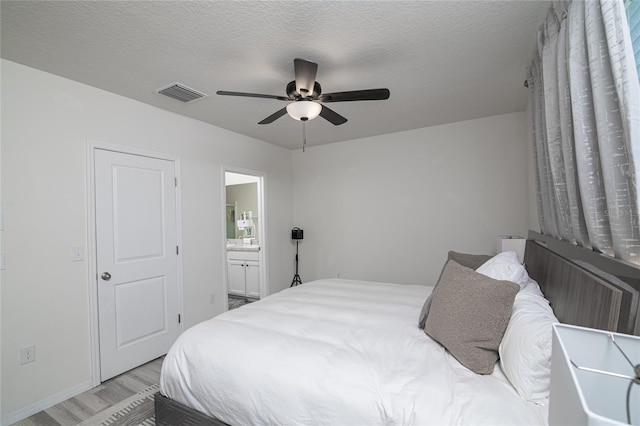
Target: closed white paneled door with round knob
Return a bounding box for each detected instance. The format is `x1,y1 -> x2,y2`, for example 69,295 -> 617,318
94,149 -> 180,381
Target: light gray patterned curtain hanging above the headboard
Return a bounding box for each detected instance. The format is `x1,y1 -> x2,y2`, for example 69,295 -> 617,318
527,0 -> 640,264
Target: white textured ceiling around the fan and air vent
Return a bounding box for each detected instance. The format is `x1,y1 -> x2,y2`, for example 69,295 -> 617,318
0,0 -> 549,149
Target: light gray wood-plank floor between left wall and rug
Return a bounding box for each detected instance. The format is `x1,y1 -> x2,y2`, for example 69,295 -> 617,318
14,357 -> 164,426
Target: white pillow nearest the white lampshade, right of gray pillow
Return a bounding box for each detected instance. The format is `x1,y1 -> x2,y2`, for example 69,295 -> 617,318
498,286 -> 558,404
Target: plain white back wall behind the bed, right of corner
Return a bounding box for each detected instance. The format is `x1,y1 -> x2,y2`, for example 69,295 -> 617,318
293,112 -> 529,285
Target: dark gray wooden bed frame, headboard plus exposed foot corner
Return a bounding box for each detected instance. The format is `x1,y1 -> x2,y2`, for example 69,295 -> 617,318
155,231 -> 640,426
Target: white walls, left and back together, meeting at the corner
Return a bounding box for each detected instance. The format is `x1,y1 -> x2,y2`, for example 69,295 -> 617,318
0,61 -> 535,417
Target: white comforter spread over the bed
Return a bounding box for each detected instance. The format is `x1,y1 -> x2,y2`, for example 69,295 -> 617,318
161,279 -> 547,425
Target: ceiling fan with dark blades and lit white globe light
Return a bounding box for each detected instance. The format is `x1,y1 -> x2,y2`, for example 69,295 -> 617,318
216,59 -> 389,126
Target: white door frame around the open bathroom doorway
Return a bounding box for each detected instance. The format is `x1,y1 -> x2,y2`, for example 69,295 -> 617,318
221,164 -> 269,311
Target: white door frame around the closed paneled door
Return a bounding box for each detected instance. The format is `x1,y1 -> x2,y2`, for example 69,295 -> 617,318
86,139 -> 184,387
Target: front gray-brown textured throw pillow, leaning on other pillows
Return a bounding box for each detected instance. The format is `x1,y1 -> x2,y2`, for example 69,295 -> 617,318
425,260 -> 520,374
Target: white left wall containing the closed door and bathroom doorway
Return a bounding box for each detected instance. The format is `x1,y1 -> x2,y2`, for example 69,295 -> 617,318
0,60 -> 293,418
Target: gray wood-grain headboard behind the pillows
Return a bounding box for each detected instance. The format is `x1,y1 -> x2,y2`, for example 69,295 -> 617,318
525,232 -> 640,335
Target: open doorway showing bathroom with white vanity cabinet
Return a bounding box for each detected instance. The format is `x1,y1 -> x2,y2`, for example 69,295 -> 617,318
224,168 -> 268,309
